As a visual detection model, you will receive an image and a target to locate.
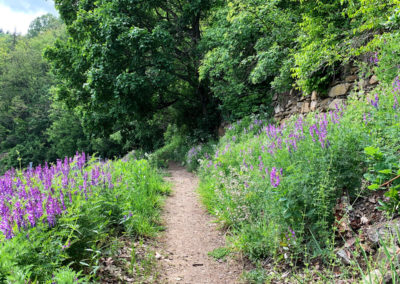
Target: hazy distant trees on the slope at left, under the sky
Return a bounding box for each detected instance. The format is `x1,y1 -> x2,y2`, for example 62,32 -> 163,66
0,15 -> 121,172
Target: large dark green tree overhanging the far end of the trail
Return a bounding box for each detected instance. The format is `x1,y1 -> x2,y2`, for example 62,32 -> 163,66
46,0 -> 219,149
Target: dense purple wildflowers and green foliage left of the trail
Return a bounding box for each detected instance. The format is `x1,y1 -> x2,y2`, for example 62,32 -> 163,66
0,154 -> 168,283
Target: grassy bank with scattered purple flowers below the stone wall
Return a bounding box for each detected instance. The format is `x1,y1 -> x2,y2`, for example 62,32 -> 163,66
199,78 -> 400,279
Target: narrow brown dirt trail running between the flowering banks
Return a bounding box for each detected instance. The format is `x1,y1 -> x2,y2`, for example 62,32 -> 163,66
160,165 -> 242,284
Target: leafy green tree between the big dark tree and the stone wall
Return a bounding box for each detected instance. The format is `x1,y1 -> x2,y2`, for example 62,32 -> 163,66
200,0 -> 299,120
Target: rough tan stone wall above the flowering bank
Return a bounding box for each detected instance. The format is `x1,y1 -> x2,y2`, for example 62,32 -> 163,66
273,69 -> 378,121
